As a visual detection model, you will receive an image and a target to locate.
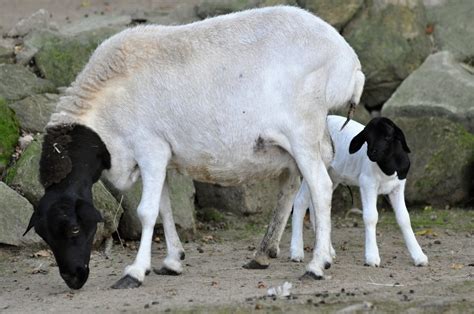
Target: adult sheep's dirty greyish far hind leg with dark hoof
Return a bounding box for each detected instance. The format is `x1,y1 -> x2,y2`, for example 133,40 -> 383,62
244,169 -> 299,269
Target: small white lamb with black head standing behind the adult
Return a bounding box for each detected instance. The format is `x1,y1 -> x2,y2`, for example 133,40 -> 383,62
290,116 -> 428,267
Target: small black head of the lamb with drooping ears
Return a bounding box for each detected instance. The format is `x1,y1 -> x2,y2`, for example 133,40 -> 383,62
349,118 -> 410,180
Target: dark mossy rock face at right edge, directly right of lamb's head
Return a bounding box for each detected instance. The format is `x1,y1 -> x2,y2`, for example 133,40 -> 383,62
393,116 -> 474,208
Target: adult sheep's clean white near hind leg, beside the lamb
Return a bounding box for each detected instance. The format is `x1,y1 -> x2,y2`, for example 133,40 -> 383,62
295,150 -> 332,279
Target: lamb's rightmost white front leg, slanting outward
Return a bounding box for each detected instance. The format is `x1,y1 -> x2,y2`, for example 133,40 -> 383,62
389,184 -> 428,266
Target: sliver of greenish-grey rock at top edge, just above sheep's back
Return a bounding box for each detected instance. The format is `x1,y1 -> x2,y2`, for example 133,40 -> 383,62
196,0 -> 260,19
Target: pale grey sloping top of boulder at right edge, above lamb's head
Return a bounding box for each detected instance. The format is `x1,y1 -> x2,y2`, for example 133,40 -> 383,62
382,51 -> 474,133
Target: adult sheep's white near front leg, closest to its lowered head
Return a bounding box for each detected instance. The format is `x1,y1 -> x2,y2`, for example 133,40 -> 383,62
112,143 -> 170,289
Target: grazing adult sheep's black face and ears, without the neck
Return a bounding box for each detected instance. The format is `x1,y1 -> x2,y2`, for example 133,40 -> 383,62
25,196 -> 102,289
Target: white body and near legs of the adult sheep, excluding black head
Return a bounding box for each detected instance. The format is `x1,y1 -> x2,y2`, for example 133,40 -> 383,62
48,7 -> 365,281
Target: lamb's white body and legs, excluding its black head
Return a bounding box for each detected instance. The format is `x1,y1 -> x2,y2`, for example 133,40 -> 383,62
291,116 -> 428,266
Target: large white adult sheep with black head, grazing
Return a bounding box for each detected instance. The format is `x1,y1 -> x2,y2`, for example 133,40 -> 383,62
23,7 -> 364,289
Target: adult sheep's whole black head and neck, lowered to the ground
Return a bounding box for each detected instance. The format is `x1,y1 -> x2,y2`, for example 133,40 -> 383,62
25,125 -> 110,289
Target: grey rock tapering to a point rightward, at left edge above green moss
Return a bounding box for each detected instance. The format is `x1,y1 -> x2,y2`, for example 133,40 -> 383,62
0,64 -> 55,102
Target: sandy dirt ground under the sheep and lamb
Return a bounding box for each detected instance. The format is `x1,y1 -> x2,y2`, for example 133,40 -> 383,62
0,210 -> 474,313
